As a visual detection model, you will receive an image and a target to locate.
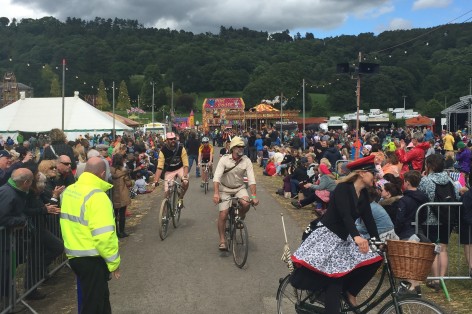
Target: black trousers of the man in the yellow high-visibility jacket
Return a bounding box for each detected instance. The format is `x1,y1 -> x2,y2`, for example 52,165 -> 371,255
69,256 -> 111,314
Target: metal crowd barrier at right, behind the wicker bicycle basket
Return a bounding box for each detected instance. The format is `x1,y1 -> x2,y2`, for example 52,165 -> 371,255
413,202 -> 472,301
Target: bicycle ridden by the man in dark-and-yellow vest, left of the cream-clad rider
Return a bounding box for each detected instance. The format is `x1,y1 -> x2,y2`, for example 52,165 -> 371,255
158,176 -> 182,240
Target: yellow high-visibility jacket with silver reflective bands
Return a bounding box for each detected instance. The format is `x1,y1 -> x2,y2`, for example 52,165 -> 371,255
60,172 -> 120,272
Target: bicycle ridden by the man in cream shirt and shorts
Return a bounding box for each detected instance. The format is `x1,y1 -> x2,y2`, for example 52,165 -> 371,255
220,195 -> 255,268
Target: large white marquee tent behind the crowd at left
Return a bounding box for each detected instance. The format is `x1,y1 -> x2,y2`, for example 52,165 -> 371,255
0,92 -> 132,140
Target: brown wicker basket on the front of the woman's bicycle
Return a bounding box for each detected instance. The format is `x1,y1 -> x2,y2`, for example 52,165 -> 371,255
387,240 -> 435,281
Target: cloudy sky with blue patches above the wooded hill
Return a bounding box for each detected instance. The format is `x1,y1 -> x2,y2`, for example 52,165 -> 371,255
0,0 -> 472,38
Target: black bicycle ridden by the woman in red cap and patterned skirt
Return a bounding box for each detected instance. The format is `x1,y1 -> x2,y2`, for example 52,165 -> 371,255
276,239 -> 444,314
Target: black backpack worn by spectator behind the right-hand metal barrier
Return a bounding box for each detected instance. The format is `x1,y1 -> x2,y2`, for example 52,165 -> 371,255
432,181 -> 459,227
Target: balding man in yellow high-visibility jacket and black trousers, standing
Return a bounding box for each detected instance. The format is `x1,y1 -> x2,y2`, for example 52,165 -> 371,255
60,157 -> 121,314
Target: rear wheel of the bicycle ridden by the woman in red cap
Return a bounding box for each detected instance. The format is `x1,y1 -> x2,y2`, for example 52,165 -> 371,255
277,274 -> 324,314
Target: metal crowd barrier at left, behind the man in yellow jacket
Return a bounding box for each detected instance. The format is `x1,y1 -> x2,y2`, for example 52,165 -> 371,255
0,215 -> 67,314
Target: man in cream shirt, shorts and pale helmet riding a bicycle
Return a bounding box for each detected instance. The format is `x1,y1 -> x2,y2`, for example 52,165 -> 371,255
213,136 -> 259,251
